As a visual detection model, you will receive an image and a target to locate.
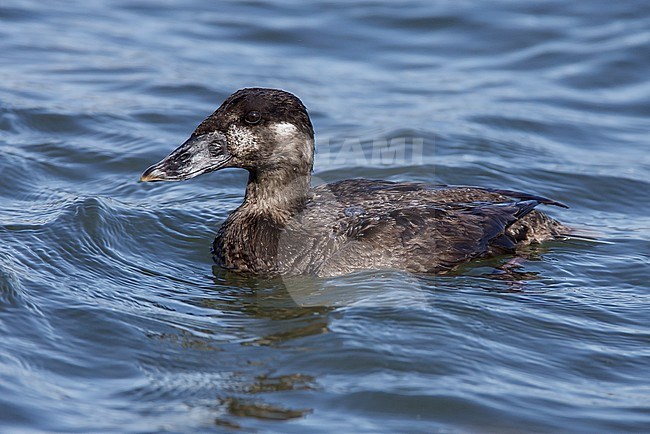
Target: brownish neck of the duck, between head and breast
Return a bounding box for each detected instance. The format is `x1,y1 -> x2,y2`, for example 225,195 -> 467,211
242,168 -> 311,220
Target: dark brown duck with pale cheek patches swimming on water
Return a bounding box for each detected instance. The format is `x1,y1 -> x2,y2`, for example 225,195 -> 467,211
140,88 -> 571,277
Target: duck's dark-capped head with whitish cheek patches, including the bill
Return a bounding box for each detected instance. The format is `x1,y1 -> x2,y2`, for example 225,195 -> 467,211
140,88 -> 314,182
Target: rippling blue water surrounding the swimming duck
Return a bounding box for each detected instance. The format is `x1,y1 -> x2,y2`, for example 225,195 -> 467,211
0,0 -> 650,433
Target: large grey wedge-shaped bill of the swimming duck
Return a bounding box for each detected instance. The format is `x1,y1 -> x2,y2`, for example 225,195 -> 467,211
140,132 -> 231,182
